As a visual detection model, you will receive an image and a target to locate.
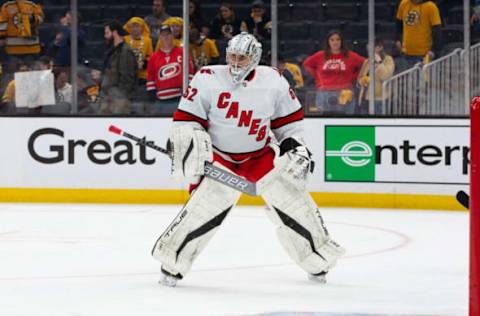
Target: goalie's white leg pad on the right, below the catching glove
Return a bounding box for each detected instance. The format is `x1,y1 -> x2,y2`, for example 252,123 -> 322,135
262,176 -> 345,274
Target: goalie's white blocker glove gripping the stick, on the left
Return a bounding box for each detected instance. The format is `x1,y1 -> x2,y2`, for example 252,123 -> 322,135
167,124 -> 213,183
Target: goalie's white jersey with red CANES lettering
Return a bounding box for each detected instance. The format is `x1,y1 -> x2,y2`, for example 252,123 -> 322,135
173,66 -> 303,162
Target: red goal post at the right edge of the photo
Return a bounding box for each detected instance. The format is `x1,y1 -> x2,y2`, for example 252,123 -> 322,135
469,97 -> 480,316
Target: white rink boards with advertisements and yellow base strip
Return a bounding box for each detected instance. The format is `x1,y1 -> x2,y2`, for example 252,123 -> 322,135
0,117 -> 470,210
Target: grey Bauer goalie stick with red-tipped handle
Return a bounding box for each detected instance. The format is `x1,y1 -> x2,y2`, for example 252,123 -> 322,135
108,125 -> 257,196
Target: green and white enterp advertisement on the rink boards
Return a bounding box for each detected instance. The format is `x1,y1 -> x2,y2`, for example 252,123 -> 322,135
324,120 -> 470,185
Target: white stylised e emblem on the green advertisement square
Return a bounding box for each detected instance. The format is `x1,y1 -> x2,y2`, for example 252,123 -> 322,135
326,141 -> 373,167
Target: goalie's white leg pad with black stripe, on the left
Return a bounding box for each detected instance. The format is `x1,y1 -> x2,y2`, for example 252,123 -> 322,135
152,165 -> 240,278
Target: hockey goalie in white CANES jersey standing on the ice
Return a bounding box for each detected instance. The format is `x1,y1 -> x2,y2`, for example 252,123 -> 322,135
152,33 -> 345,286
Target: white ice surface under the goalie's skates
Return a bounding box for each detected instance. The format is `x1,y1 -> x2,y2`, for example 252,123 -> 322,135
0,204 -> 468,316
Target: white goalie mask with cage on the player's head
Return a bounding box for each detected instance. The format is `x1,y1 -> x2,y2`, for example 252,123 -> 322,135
227,32 -> 262,84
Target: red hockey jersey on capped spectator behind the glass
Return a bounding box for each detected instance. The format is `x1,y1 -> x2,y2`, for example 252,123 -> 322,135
147,47 -> 193,100
